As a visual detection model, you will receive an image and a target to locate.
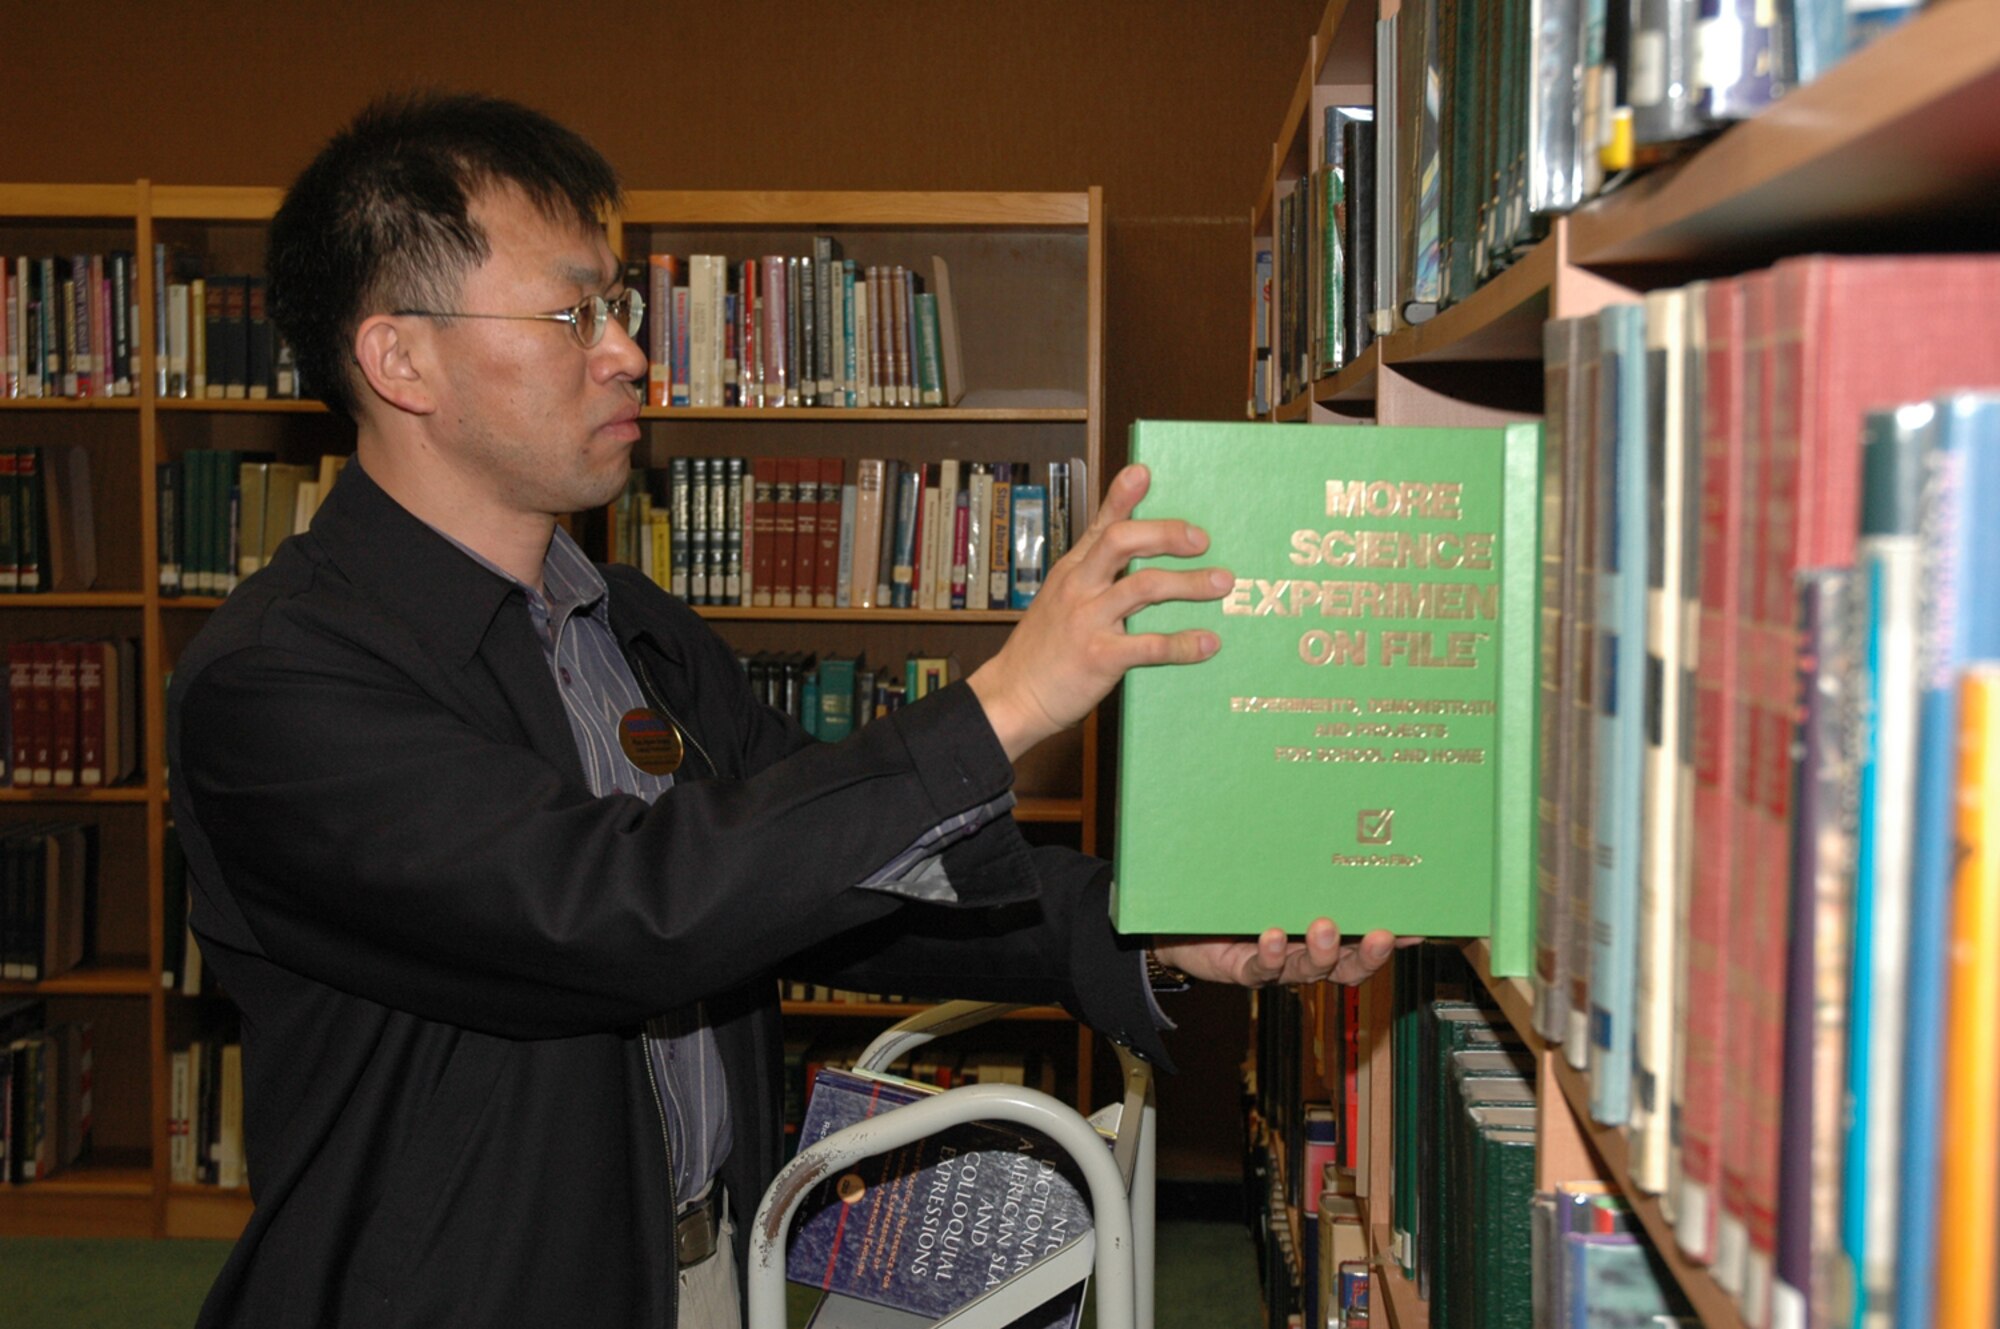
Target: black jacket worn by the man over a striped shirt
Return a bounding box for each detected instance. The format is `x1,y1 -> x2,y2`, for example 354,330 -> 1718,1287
168,466 -> 1160,1327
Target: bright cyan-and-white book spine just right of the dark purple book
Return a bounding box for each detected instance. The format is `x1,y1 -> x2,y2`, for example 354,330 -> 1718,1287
1840,402 -> 1932,1329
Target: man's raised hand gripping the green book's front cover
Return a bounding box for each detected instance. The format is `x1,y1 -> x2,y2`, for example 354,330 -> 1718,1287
966,466 -> 1234,761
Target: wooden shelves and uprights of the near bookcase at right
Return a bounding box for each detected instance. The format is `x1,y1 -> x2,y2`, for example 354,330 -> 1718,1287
1248,0 -> 2000,1329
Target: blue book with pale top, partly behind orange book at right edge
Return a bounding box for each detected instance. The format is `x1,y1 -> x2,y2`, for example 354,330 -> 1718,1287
1896,394 -> 2000,1325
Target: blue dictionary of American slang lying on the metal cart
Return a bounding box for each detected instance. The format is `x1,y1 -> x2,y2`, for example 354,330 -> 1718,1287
784,1071 -> 1090,1329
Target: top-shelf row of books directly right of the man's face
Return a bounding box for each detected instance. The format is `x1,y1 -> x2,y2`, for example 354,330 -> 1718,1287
626,236 -> 964,406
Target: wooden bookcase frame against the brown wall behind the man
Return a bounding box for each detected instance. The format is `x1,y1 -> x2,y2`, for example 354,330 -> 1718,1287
0,180 -> 1104,1237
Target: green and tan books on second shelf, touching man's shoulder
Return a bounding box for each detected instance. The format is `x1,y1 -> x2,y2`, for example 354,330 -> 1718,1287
154,448 -> 348,594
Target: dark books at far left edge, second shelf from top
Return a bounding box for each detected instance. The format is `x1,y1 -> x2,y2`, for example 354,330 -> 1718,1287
0,444 -> 98,594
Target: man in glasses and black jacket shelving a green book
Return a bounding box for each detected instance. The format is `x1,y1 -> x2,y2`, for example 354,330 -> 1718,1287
168,96 -> 1390,1329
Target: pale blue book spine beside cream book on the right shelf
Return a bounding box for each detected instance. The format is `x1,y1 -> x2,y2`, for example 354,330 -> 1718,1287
1590,304 -> 1646,1125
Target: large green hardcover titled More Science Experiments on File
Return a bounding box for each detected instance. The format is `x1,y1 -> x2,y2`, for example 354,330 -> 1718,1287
1112,422 -> 1540,940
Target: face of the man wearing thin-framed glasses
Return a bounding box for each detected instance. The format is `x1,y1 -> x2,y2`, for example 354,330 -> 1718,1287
432,188 -> 646,514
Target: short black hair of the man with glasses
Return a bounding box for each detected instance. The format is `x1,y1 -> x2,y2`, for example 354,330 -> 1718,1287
266,92 -> 620,418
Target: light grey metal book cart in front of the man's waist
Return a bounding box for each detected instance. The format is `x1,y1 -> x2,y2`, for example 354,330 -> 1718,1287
746,1001 -> 1156,1329
